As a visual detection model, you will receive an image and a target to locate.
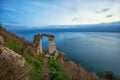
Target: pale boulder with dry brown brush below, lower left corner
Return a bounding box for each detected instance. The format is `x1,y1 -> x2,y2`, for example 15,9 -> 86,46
0,41 -> 26,80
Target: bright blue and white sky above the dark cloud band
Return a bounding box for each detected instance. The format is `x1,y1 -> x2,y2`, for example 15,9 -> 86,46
0,0 -> 120,28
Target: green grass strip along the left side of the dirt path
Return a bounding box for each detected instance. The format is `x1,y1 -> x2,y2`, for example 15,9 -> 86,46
23,54 -> 43,80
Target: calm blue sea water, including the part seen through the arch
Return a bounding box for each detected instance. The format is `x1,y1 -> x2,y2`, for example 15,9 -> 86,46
15,32 -> 120,75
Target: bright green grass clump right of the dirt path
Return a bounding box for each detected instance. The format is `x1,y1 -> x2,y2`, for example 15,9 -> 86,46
48,58 -> 70,80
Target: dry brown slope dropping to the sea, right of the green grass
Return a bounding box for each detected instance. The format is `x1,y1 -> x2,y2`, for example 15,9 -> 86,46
57,52 -> 100,80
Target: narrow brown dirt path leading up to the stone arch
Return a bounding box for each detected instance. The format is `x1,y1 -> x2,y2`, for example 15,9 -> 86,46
42,58 -> 50,80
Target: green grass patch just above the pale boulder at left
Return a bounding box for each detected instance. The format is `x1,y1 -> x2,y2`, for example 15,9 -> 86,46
5,40 -> 24,53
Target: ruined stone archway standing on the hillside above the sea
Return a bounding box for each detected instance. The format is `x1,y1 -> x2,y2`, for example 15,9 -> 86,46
34,34 -> 58,58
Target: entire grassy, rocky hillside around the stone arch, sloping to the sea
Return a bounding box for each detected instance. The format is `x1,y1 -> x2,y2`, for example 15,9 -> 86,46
0,27 -> 119,80
